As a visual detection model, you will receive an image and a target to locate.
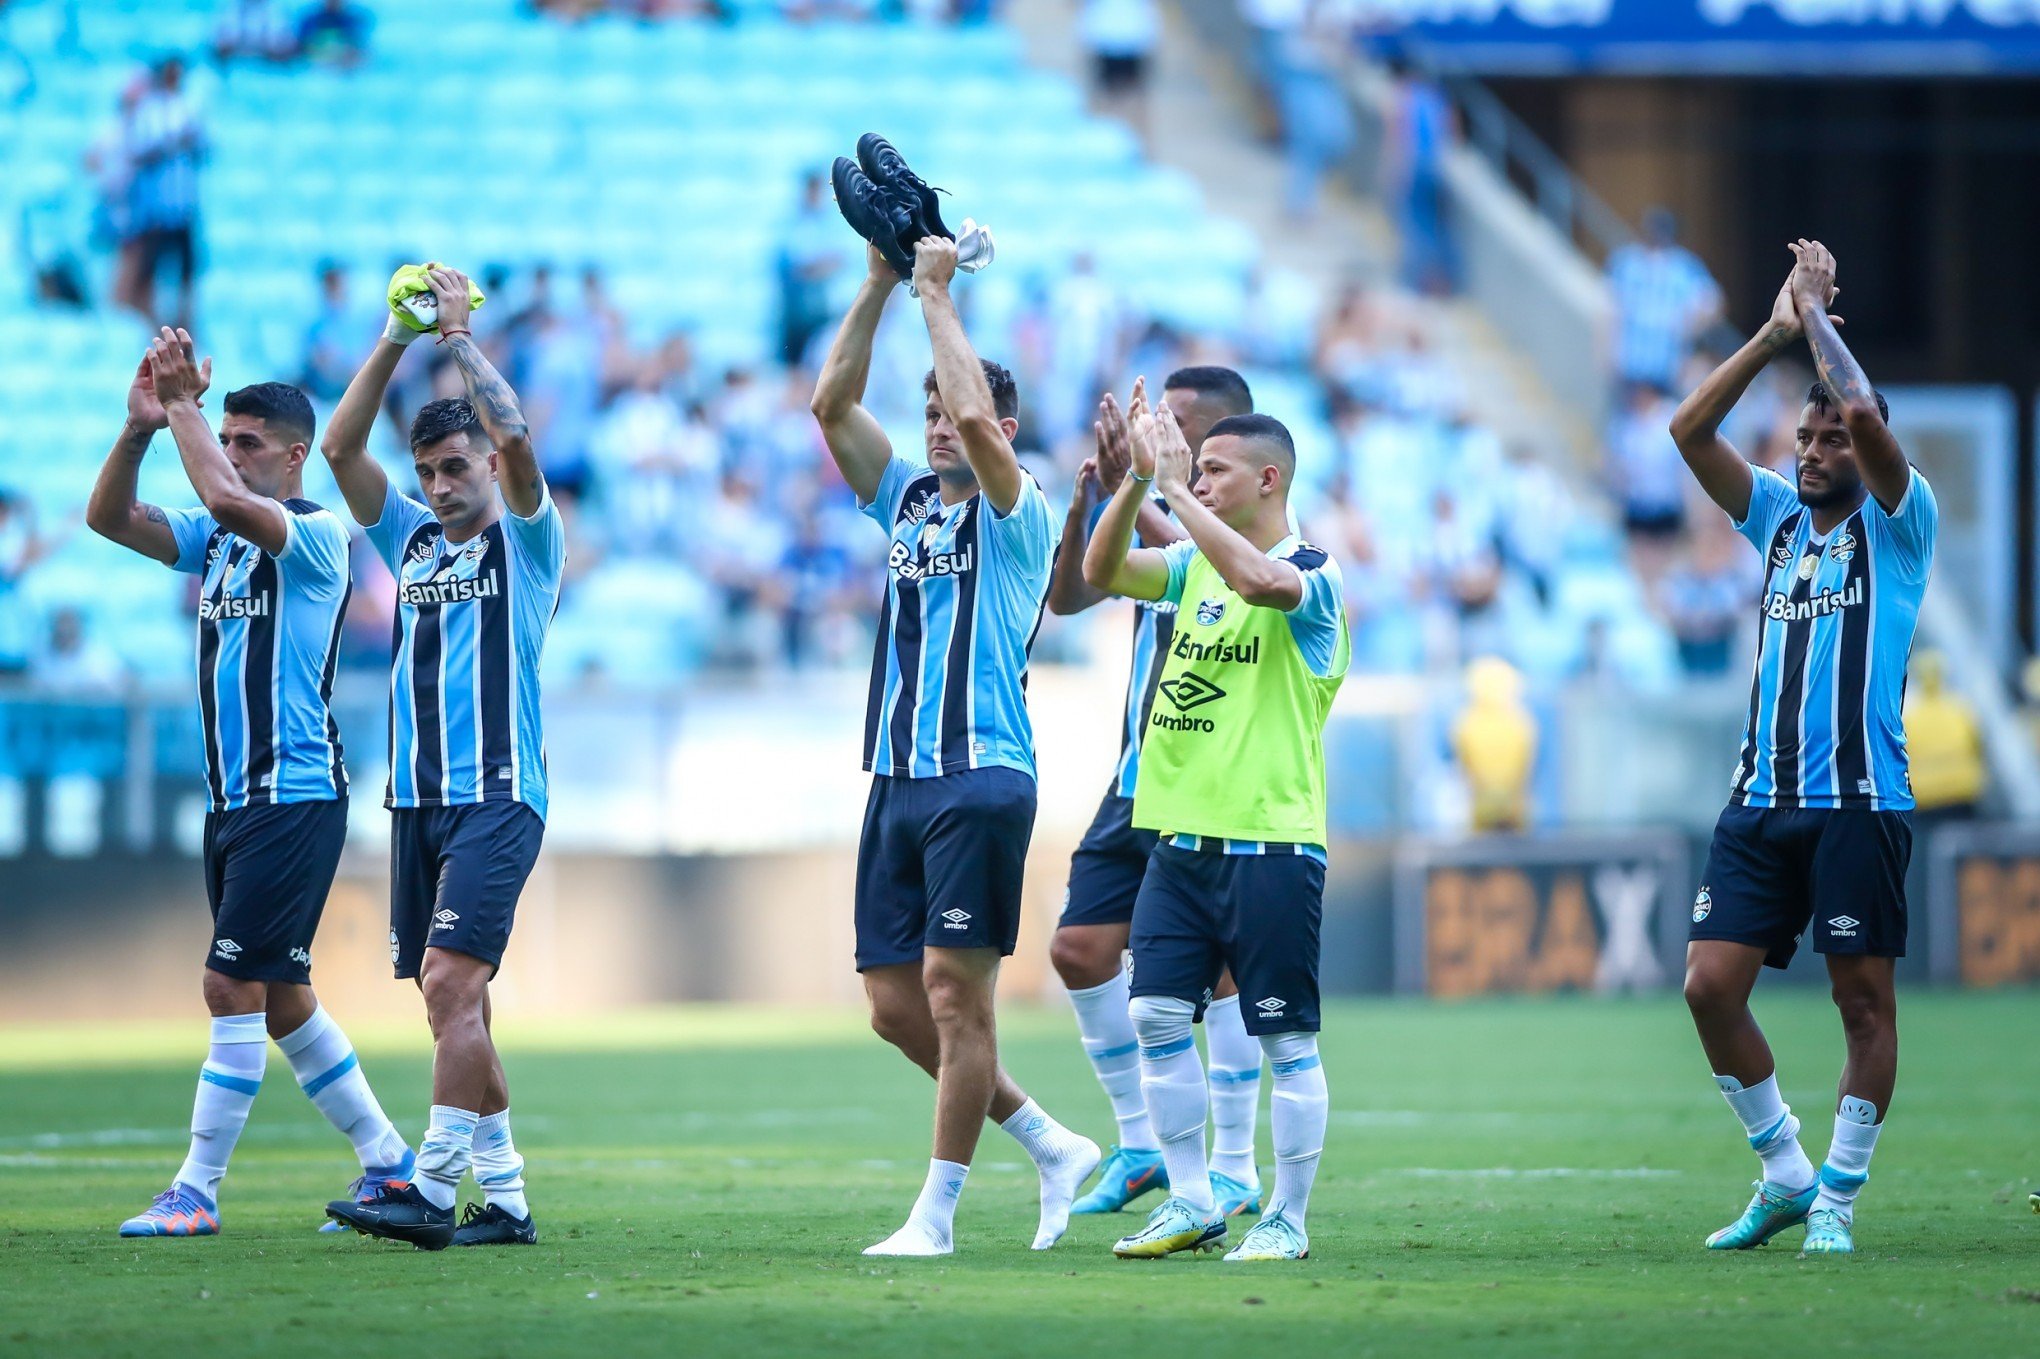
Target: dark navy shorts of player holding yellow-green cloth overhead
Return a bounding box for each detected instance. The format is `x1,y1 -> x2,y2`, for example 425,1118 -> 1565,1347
390,802 -> 545,977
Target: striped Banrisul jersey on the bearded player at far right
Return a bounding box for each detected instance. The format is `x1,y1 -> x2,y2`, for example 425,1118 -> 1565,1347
1732,467 -> 1940,812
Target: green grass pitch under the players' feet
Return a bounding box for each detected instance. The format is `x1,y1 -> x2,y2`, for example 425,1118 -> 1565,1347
0,992 -> 2040,1359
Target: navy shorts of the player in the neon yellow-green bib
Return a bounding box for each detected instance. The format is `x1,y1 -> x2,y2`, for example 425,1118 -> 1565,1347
1132,845 -> 1324,1037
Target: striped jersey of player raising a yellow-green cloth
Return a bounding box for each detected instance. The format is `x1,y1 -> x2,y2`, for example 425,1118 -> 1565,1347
369,486 -> 567,816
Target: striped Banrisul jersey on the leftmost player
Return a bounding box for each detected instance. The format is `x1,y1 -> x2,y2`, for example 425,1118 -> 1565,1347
163,500 -> 349,812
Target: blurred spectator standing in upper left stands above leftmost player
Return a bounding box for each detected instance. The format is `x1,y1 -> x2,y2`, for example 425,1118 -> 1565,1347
114,57 -> 206,326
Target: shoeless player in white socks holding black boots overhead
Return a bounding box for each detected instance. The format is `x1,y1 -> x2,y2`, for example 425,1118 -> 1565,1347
812,237 -> 1100,1255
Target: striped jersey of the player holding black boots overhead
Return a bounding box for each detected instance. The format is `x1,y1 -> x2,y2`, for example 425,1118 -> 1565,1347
861,455 -> 1059,779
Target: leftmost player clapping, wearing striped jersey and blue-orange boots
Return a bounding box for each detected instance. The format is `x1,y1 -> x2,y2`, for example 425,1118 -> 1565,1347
86,331 -> 412,1237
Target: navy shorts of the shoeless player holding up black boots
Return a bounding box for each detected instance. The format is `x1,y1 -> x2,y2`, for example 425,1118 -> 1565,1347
857,765 -> 1034,971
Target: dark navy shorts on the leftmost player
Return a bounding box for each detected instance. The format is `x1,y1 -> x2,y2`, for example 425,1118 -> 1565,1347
206,798 -> 347,986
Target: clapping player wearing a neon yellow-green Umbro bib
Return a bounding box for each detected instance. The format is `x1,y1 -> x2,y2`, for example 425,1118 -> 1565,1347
1083,384 -> 1353,1261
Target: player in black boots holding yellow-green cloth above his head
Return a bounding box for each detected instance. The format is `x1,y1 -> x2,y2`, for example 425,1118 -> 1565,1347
320,267 -> 567,1251
